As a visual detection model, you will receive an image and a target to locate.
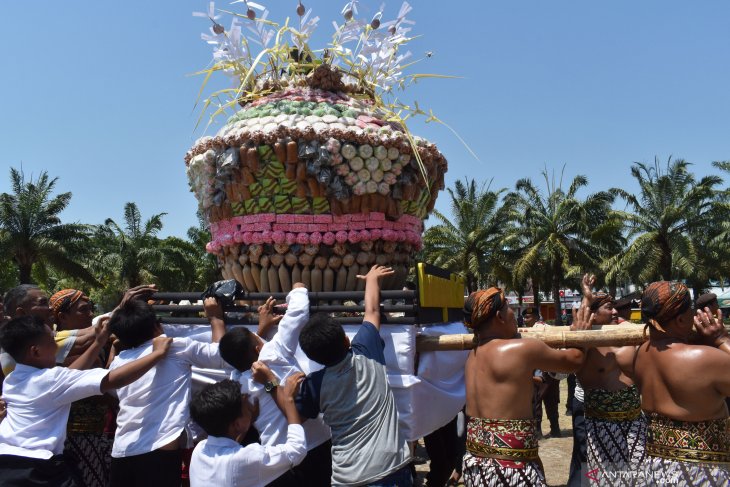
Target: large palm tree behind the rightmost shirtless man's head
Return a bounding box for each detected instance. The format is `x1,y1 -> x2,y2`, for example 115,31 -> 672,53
604,157 -> 722,282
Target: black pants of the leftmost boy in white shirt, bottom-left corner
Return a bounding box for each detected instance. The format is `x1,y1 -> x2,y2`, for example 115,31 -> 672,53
0,455 -> 79,487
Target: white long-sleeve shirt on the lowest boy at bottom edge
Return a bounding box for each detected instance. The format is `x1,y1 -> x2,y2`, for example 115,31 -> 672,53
190,424 -> 307,487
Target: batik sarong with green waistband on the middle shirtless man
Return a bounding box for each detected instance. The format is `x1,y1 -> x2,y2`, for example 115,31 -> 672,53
585,386 -> 646,485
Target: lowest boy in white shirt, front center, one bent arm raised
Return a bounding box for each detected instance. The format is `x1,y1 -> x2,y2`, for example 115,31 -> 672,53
190,376 -> 307,487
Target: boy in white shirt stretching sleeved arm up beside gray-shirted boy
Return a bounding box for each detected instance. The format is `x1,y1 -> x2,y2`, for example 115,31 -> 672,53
220,282 -> 332,487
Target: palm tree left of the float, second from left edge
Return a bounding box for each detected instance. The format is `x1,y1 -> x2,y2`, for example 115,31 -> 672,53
96,203 -> 195,289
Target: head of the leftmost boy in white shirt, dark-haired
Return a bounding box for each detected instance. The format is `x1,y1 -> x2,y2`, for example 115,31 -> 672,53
0,316 -> 58,368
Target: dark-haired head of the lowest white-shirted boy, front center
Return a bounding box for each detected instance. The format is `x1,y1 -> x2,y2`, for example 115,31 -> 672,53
190,379 -> 254,438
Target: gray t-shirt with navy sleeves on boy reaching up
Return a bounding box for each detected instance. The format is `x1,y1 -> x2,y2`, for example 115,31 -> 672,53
297,322 -> 410,485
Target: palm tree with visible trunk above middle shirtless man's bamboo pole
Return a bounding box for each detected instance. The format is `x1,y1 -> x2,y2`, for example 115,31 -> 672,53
504,171 -> 613,321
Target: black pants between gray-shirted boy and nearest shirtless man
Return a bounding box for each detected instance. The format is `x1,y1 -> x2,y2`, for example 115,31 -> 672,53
423,416 -> 464,487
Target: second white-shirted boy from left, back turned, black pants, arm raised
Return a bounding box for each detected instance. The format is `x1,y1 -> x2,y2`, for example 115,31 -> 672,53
109,298 -> 225,487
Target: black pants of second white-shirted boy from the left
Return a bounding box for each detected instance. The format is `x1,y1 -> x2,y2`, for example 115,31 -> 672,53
111,450 -> 182,487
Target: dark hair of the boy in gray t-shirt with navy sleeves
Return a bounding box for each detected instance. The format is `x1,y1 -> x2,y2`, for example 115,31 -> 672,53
299,313 -> 348,366
